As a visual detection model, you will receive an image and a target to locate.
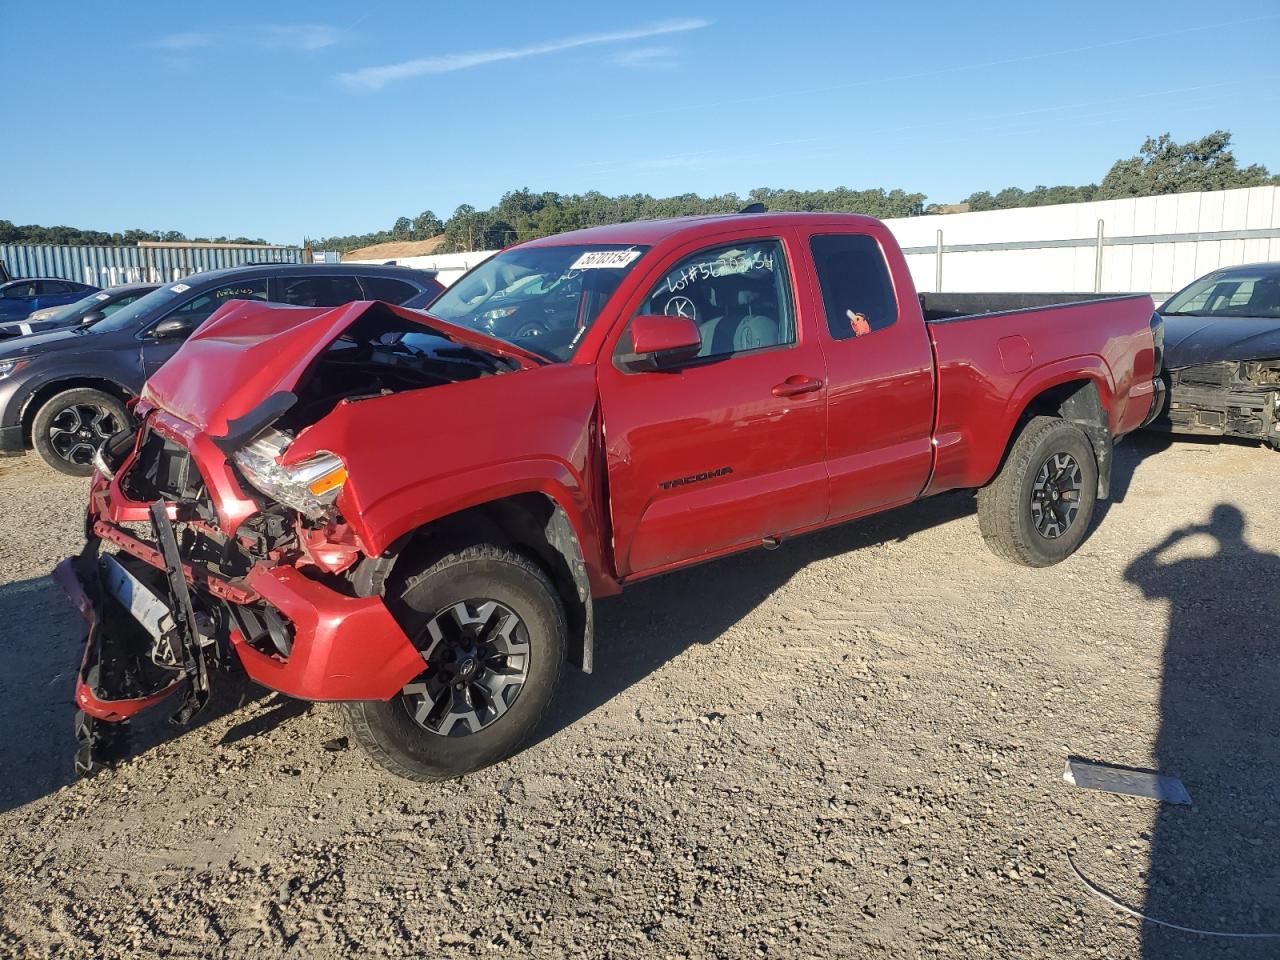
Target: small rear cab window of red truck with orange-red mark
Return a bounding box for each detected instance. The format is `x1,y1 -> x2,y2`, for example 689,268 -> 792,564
809,233 -> 897,340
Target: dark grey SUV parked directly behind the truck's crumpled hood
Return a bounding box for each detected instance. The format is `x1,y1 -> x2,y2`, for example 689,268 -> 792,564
0,264 -> 444,476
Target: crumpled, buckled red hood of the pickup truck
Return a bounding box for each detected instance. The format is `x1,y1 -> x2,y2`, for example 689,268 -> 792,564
142,301 -> 538,436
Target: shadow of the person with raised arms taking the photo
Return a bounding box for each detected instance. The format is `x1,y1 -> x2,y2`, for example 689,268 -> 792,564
1125,503 -> 1280,960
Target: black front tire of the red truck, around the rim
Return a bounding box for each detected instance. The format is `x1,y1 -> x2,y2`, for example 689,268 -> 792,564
342,544 -> 568,782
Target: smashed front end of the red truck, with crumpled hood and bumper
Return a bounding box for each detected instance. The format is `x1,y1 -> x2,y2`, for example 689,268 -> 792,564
54,303 -> 521,773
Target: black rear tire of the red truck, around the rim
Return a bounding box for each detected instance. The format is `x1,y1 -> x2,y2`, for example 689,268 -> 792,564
978,416 -> 1098,567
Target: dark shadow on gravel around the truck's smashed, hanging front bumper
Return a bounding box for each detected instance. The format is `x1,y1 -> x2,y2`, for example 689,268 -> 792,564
0,577 -> 288,813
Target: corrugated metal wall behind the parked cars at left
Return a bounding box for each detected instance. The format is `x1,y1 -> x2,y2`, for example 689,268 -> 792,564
0,243 -> 302,287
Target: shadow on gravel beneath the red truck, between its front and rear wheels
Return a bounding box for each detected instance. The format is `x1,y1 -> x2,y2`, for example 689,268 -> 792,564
535,492 -> 974,742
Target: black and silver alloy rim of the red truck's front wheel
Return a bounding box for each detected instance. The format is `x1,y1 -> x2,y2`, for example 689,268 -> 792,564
401,599 -> 530,737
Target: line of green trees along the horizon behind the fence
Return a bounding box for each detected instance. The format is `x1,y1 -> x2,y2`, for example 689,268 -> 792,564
0,131 -> 1280,253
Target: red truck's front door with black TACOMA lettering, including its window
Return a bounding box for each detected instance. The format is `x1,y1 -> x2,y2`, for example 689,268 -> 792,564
598,234 -> 828,577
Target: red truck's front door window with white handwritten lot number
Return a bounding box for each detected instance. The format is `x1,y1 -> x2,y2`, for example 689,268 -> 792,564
639,241 -> 796,358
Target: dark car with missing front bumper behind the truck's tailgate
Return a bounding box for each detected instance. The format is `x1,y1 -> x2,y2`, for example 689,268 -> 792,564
1152,264 -> 1280,449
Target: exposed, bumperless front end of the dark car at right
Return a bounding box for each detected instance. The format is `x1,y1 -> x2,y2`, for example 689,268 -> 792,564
1152,360 -> 1280,449
